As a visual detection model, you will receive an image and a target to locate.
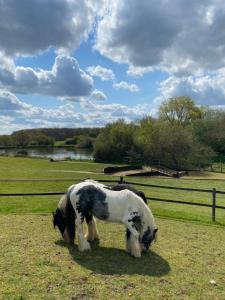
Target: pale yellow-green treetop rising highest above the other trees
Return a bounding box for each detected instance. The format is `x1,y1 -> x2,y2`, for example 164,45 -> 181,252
159,96 -> 203,126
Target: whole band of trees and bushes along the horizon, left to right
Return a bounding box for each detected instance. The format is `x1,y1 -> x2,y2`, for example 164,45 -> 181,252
0,96 -> 225,170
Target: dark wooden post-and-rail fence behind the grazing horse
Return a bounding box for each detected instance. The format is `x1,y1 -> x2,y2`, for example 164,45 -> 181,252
0,177 -> 225,222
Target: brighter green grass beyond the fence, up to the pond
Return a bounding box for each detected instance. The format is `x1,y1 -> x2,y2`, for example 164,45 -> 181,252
0,157 -> 225,225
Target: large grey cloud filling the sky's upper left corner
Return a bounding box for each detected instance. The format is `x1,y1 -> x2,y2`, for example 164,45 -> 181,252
0,0 -> 99,55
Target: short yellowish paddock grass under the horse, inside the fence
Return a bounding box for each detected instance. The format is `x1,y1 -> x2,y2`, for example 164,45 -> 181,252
0,215 -> 225,299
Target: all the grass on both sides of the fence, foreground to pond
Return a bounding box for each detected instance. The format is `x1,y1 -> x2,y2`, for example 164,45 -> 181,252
0,157 -> 225,300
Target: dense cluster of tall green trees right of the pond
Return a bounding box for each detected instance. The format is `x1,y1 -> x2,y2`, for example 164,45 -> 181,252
94,96 -> 225,170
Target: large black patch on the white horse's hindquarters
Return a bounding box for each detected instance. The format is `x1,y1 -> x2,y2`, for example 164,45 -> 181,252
77,185 -> 109,220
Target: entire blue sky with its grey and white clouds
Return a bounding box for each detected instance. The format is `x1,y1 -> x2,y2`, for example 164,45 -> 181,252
0,0 -> 225,134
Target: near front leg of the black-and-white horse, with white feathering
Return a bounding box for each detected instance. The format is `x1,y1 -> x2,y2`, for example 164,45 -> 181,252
124,220 -> 141,257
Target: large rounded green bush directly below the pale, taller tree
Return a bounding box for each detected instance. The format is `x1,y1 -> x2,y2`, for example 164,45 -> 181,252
135,120 -> 213,170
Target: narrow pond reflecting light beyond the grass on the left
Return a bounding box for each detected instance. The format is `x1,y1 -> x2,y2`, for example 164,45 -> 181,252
0,148 -> 93,160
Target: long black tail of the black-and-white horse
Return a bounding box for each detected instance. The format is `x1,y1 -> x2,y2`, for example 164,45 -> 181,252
65,190 -> 76,244
